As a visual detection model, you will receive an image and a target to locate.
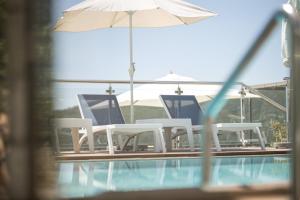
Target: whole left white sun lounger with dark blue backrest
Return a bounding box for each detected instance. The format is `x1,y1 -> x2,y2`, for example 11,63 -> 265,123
78,94 -> 166,154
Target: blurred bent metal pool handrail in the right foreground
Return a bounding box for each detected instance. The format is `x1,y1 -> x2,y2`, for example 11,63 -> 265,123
202,4 -> 300,199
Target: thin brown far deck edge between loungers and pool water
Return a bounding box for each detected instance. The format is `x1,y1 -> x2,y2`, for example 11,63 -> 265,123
56,147 -> 291,160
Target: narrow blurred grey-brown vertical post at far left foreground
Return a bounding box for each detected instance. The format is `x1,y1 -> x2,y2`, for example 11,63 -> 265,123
6,0 -> 33,199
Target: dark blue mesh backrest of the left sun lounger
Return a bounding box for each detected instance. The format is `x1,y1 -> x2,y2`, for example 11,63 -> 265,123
78,94 -> 125,126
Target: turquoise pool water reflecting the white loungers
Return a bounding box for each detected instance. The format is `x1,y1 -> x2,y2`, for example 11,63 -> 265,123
58,156 -> 290,197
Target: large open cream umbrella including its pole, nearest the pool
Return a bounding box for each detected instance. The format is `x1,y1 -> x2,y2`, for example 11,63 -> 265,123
55,0 -> 216,123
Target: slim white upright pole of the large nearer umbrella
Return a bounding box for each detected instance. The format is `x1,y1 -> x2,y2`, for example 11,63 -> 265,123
128,11 -> 135,123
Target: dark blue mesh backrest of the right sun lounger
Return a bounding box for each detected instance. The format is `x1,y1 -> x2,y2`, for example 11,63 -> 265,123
160,95 -> 203,125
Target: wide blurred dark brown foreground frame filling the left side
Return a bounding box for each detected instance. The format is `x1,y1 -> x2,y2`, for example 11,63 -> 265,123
6,0 -> 55,199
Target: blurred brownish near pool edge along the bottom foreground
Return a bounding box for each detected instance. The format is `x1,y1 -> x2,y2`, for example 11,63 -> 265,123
70,184 -> 291,200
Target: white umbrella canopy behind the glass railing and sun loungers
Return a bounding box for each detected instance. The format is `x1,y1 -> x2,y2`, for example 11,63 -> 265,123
117,73 -> 257,107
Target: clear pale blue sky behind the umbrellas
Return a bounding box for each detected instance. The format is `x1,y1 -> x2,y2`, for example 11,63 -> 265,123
52,0 -> 288,109
